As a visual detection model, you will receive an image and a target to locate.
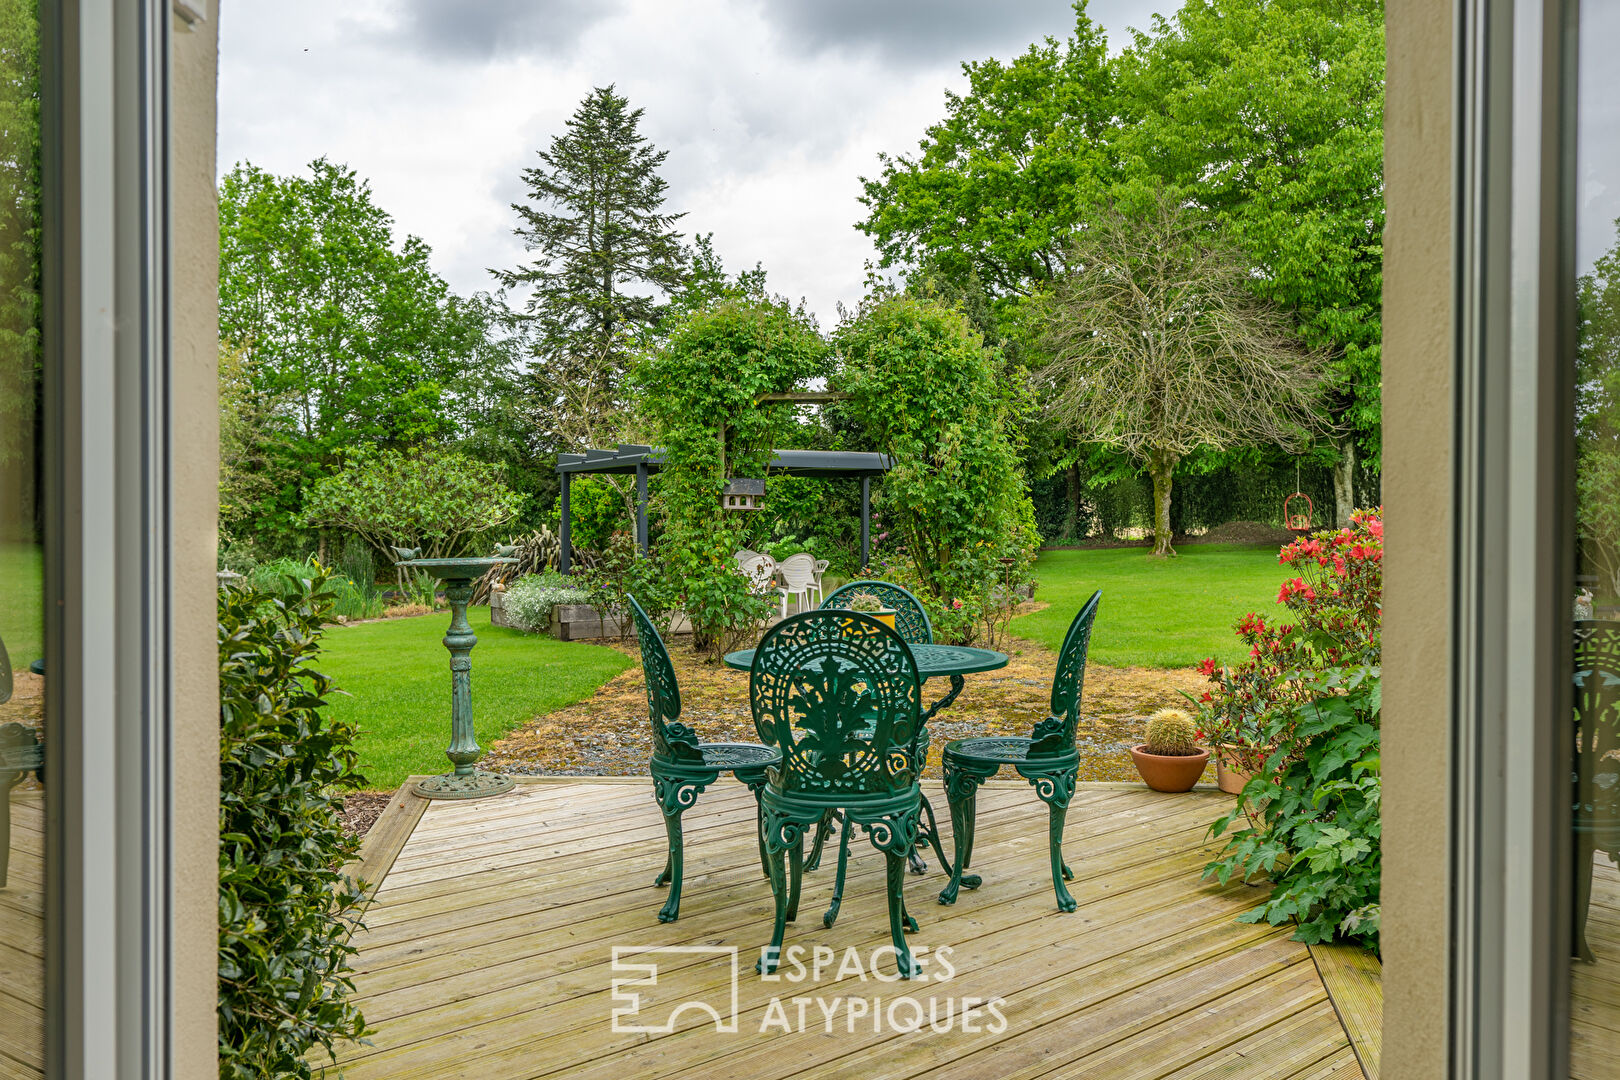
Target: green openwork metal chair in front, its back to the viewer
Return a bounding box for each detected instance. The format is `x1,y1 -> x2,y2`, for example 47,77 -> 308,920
748,610 -> 922,978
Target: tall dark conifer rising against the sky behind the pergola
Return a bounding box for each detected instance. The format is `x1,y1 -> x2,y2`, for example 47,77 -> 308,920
494,86 -> 685,450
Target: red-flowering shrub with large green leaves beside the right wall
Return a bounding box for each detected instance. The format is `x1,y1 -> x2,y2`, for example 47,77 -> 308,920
1199,510 -> 1383,949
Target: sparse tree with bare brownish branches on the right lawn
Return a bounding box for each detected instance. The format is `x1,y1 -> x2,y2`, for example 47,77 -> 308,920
1037,194 -> 1327,555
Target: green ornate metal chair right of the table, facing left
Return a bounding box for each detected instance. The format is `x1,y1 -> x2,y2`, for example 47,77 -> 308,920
940,589 -> 1103,912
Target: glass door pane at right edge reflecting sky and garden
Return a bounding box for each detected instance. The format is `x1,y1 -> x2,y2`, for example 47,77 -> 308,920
1570,0 -> 1620,1080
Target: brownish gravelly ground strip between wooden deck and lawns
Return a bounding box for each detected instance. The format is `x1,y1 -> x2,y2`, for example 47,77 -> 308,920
480,625 -> 1205,780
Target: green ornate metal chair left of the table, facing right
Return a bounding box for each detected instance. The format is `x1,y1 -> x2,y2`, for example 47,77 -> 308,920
630,596 -> 782,923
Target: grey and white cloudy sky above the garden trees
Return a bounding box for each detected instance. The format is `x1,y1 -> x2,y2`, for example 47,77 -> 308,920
219,0 -> 1176,324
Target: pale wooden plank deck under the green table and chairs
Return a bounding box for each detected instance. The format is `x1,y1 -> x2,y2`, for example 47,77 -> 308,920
325,779 -> 1377,1080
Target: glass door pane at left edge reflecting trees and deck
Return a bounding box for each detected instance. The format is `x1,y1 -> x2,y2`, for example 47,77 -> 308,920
0,0 -> 45,1077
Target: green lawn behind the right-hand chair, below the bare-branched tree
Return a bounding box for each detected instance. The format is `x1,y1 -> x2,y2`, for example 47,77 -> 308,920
1013,544 -> 1294,667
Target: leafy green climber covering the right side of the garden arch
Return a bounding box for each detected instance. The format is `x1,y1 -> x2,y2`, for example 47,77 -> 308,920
833,296 -> 1035,640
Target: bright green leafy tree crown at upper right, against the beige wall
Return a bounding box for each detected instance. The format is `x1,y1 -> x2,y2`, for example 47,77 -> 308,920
1115,0 -> 1383,460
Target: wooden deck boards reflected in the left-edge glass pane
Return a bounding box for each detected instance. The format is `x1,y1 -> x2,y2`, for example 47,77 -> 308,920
0,786 -> 45,1080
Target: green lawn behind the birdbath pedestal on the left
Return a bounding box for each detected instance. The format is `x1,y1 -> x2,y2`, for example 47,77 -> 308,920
321,607 -> 630,790
